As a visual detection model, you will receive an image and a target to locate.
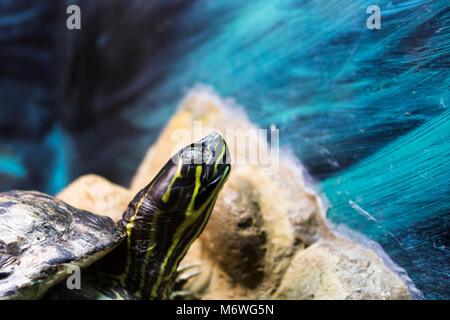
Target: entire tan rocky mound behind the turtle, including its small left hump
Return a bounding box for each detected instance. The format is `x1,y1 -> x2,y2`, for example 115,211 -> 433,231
60,89 -> 410,299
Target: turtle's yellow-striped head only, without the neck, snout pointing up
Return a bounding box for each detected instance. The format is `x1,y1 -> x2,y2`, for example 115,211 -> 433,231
161,133 -> 230,215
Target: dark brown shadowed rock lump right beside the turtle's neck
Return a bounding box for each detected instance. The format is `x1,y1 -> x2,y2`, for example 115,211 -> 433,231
202,177 -> 267,289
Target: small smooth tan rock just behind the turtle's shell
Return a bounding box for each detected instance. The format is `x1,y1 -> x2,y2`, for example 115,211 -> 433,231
56,174 -> 134,221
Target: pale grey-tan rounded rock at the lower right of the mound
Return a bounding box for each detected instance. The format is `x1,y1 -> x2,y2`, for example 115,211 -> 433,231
274,238 -> 410,300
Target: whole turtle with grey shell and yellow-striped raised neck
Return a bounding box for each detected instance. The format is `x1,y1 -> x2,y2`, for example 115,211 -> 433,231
0,133 -> 231,300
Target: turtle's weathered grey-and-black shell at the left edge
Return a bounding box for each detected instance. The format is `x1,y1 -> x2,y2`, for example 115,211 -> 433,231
0,191 -> 125,299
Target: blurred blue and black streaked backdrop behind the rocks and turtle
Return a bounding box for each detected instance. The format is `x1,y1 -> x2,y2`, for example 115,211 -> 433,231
0,0 -> 450,299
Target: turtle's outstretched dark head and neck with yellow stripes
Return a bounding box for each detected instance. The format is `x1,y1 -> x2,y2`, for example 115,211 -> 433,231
119,133 -> 230,299
